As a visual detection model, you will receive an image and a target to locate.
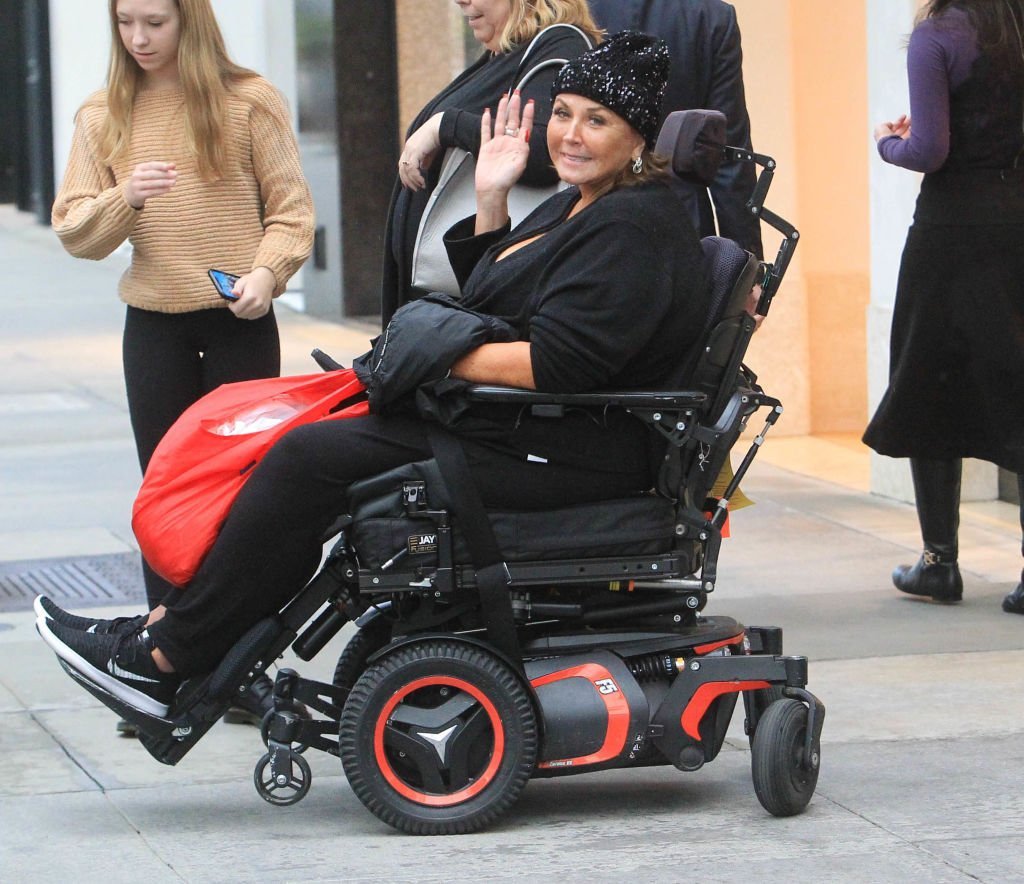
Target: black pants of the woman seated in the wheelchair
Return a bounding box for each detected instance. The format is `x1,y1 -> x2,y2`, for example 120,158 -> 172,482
150,416 -> 651,676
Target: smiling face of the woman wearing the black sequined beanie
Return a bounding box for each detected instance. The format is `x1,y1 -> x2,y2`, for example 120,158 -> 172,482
548,92 -> 644,201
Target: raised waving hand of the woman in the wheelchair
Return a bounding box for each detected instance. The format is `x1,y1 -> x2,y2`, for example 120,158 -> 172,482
476,92 -> 534,200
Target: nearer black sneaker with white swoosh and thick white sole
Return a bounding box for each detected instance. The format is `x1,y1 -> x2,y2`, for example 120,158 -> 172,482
36,617 -> 181,717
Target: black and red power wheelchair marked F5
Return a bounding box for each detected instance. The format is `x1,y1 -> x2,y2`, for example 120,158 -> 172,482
58,111 -> 824,834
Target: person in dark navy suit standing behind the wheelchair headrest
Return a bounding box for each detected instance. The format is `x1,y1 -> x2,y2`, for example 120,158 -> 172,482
589,0 -> 764,258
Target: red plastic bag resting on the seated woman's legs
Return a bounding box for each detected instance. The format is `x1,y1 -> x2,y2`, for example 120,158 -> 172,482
131,369 -> 370,586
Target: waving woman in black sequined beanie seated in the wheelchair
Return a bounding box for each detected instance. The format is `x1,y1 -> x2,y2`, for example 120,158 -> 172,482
37,33 -> 708,716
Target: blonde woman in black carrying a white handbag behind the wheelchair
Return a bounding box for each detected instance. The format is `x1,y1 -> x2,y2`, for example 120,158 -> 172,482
381,0 -> 600,325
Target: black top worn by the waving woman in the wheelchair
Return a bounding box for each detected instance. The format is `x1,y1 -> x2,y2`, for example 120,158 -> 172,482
445,183 -> 708,471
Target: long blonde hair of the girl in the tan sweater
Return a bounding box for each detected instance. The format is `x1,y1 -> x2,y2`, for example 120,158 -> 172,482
99,0 -> 257,179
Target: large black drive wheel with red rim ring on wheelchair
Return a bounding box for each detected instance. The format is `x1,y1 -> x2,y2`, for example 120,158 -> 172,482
339,640 -> 538,835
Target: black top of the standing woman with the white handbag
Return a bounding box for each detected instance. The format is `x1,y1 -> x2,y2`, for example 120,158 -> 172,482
381,28 -> 587,325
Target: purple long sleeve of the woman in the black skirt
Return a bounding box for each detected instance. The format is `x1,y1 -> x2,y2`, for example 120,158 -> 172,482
878,7 -> 978,172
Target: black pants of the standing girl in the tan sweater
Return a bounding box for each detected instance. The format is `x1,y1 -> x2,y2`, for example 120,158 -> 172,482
122,307 -> 281,608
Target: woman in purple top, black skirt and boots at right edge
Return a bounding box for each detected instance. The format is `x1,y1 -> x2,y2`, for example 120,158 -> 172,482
864,0 -> 1024,614
